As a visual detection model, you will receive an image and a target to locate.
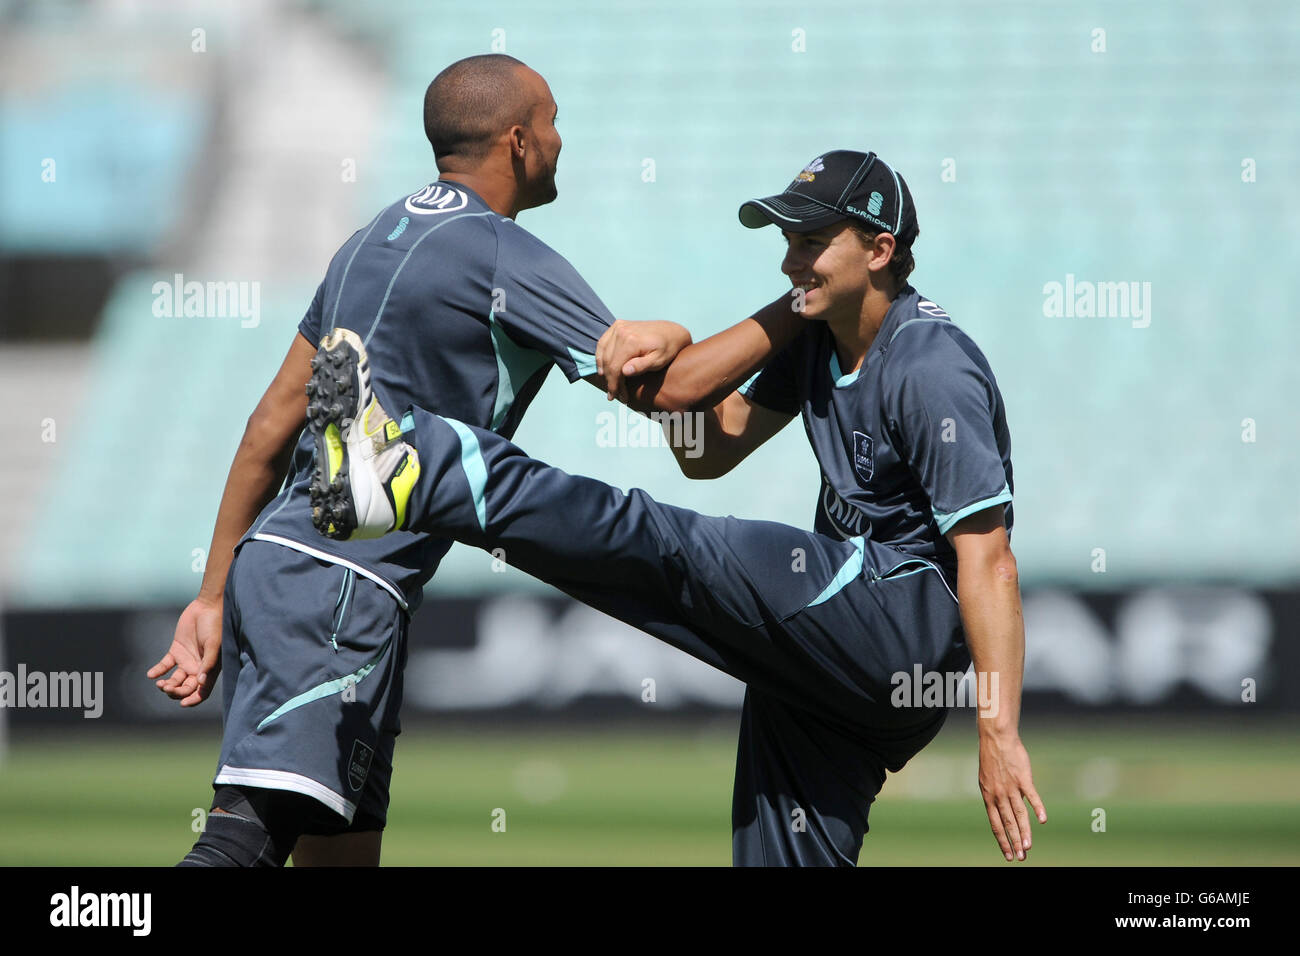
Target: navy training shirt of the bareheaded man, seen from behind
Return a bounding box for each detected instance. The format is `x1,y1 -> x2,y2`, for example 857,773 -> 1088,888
244,181 -> 614,610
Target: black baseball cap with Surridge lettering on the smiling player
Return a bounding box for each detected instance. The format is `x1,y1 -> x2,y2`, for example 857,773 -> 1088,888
740,150 -> 918,246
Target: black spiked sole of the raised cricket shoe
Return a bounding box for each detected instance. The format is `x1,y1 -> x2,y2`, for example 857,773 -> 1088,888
307,329 -> 369,541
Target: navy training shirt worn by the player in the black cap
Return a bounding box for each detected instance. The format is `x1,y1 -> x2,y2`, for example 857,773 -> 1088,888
740,286 -> 1014,587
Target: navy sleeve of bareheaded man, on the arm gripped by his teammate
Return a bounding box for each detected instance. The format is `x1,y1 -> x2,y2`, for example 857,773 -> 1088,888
493,226 -> 614,382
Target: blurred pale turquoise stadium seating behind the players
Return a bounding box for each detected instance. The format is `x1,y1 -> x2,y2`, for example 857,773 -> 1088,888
7,0 -> 1300,602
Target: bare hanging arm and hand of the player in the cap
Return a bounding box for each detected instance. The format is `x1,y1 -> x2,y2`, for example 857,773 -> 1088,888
948,505 -> 1048,860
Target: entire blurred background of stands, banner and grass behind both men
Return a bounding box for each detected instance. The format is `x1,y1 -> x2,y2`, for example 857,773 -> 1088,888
0,0 -> 1300,865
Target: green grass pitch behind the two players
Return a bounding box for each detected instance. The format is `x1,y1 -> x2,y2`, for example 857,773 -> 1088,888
0,717 -> 1300,866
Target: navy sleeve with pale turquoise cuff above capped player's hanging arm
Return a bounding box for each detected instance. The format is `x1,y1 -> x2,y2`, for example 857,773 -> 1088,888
884,323 -> 1011,535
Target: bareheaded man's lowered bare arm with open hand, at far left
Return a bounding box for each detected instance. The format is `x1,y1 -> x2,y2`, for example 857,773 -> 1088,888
148,334 -> 316,708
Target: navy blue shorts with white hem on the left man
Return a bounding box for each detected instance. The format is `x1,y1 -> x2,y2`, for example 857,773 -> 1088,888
213,541 -> 407,832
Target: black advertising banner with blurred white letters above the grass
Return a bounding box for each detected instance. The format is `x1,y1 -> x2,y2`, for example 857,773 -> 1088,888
0,587 -> 1300,727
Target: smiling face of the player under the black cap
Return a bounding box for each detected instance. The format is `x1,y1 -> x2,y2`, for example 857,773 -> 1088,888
781,220 -> 871,321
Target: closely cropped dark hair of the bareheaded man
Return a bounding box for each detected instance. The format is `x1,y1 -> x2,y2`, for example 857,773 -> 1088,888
424,53 -> 534,169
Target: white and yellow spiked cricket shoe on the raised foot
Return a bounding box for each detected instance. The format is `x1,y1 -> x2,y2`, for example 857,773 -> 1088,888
307,329 -> 420,541
